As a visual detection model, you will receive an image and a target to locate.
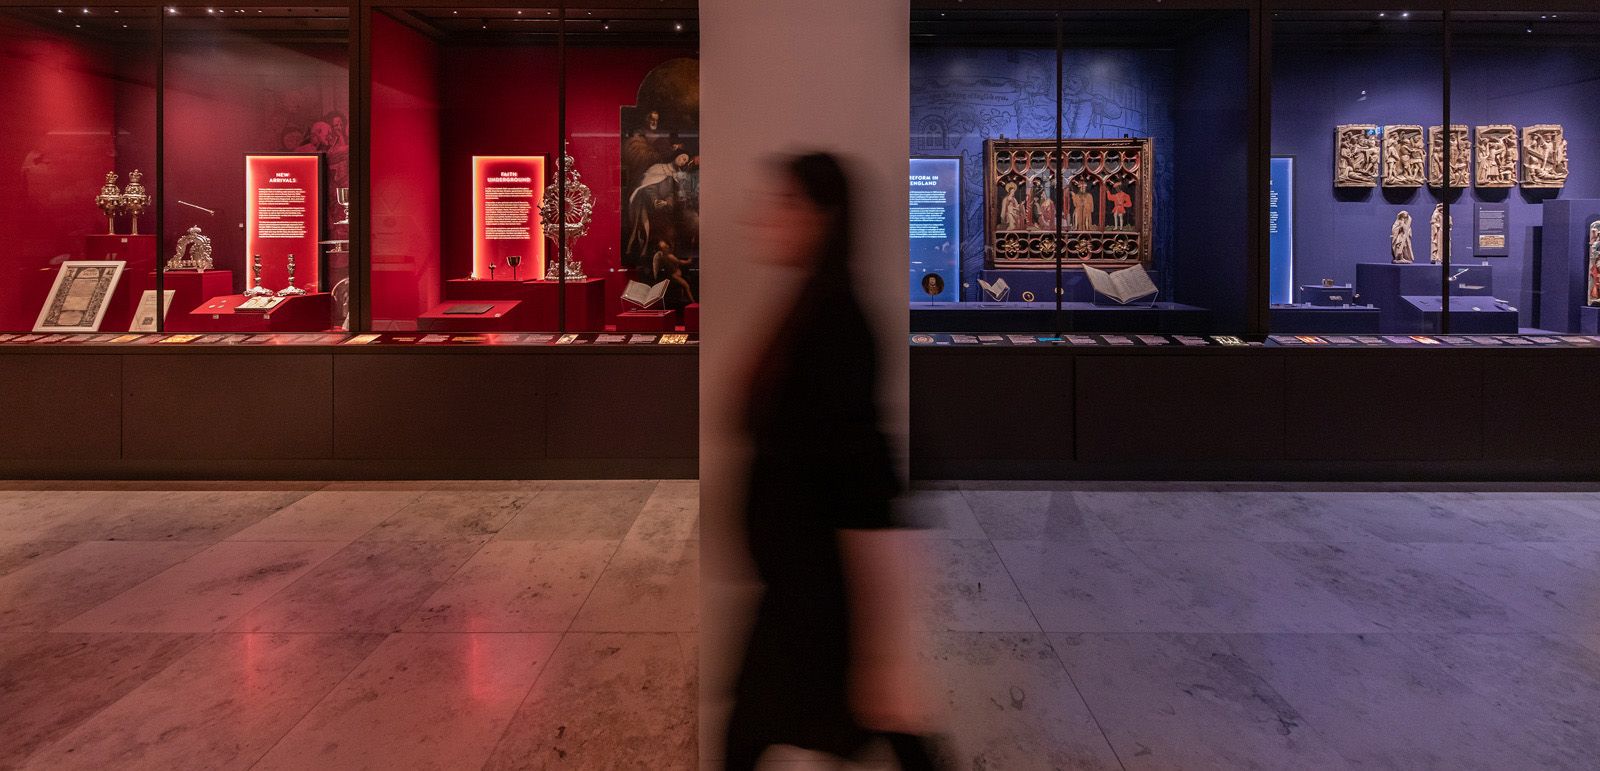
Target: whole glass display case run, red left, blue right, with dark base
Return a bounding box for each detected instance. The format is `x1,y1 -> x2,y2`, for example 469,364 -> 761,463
0,0 -> 1600,478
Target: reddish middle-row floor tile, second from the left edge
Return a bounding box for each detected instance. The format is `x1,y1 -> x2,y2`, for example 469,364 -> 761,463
56,542 -> 344,632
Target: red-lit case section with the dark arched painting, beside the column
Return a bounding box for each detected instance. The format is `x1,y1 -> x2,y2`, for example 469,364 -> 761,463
370,2 -> 699,333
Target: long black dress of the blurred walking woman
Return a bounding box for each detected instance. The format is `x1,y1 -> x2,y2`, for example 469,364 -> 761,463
728,271 -> 898,768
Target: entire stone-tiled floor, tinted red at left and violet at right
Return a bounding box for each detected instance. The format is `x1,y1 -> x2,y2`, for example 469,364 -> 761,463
0,480 -> 1600,771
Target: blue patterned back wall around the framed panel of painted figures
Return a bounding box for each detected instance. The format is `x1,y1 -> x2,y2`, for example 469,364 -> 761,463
910,48 -> 1174,301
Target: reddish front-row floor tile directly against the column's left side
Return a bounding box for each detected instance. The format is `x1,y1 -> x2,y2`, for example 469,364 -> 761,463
483,633 -> 699,771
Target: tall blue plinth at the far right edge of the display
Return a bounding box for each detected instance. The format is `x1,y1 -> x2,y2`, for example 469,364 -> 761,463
1538,198 -> 1600,334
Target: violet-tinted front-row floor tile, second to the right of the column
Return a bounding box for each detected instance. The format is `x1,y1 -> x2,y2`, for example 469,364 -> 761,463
1050,635 -> 1350,771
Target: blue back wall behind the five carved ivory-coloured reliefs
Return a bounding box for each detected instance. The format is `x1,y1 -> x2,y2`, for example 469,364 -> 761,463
1272,38 -> 1600,326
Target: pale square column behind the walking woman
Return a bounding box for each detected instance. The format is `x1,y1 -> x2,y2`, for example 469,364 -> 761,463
699,0 -> 910,760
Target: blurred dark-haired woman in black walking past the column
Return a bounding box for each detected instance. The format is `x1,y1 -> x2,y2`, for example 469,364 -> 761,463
726,154 -> 934,771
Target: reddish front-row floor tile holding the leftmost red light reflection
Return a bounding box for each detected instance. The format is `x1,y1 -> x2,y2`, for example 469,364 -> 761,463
29,635 -> 382,771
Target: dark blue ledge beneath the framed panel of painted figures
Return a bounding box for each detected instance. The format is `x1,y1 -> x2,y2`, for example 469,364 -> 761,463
910,302 -> 1211,334
